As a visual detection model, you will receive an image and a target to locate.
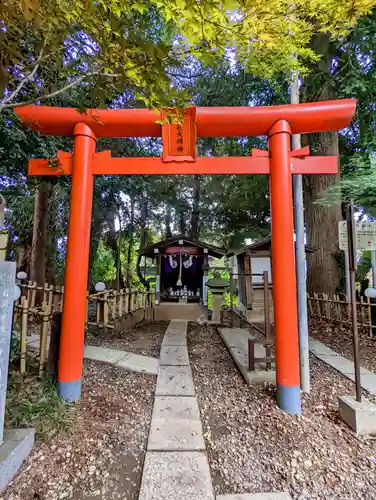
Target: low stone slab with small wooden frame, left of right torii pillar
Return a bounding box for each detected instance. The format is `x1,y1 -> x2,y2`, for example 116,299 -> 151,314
218,328 -> 276,385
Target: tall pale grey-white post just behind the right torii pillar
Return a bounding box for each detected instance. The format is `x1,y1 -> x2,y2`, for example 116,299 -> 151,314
291,76 -> 310,394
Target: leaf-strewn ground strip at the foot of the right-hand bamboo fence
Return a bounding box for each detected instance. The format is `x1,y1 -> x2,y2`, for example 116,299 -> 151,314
310,318 -> 376,374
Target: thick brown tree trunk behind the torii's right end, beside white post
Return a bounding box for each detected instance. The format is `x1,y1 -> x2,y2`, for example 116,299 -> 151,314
302,34 -> 343,294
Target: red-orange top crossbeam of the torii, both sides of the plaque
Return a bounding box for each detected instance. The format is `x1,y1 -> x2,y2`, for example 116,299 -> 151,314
16,99 -> 356,137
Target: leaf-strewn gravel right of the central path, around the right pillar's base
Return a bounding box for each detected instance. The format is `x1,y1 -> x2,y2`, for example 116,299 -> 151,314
188,325 -> 376,500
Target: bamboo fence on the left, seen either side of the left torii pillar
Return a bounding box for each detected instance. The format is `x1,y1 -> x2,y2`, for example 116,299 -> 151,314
13,281 -> 153,377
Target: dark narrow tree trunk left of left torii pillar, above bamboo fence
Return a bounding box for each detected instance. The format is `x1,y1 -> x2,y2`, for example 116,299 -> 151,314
30,179 -> 53,285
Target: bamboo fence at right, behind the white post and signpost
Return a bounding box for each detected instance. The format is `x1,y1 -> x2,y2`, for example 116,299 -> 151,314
307,293 -> 376,338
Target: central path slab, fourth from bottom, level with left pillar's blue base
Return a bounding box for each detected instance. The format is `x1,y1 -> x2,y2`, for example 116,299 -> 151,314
155,366 -> 196,396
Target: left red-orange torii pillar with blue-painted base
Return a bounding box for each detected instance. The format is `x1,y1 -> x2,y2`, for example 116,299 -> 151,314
59,123 -> 96,401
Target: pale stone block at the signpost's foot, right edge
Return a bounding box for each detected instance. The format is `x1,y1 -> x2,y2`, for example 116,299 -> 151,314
338,396 -> 376,436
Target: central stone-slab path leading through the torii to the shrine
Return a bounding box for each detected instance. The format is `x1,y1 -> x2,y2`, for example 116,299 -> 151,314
139,320 -> 214,500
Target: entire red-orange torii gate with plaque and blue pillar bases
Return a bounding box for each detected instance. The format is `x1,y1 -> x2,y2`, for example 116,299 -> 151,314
16,99 -> 356,414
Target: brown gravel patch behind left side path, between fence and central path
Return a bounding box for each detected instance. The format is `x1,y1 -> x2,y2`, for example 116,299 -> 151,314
85,321 -> 168,358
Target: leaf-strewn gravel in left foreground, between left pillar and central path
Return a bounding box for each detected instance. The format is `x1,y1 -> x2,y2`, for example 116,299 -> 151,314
0,361 -> 156,500
